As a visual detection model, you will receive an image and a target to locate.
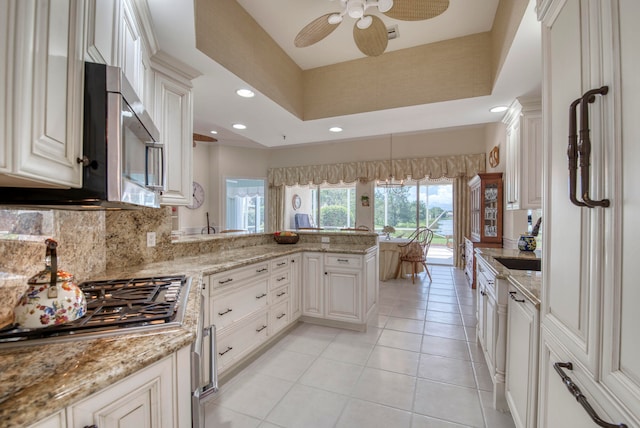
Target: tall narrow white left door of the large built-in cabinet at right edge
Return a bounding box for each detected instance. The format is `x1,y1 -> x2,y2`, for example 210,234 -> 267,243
541,0 -> 604,373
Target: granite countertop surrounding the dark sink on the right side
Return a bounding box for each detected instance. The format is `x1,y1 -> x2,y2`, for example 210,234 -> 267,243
475,248 -> 542,309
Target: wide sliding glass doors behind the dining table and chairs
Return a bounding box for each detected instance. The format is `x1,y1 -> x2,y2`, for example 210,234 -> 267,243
374,180 -> 453,244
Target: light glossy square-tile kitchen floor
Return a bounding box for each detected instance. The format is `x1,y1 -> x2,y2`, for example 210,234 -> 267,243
205,266 -> 514,428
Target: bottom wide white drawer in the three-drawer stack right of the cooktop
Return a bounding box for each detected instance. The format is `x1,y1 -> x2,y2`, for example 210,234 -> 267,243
216,311 -> 268,372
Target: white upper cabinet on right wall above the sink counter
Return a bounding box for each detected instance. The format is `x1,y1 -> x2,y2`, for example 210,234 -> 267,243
503,98 -> 543,210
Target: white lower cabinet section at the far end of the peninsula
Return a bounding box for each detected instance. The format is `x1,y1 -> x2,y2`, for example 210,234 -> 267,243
302,251 -> 378,329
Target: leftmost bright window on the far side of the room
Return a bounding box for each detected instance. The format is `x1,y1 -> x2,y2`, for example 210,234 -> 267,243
225,178 -> 265,233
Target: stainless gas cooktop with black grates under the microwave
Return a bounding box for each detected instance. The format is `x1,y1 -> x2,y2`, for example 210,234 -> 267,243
0,275 -> 191,349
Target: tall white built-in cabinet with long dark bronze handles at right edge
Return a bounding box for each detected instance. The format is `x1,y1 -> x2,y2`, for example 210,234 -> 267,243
538,0 -> 640,427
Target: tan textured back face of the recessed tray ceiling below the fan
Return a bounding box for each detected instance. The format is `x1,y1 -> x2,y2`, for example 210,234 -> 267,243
303,33 -> 492,120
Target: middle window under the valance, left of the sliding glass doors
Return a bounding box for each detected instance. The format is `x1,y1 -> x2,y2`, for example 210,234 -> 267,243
311,184 -> 356,229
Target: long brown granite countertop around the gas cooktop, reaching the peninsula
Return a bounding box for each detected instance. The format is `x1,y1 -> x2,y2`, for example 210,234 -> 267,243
0,244 -> 375,428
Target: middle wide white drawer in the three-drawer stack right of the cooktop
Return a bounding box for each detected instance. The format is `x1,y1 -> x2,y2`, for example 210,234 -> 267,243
210,278 -> 268,330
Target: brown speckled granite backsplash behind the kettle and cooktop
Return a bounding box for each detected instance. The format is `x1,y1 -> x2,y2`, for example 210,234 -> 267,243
0,207 -> 173,321
